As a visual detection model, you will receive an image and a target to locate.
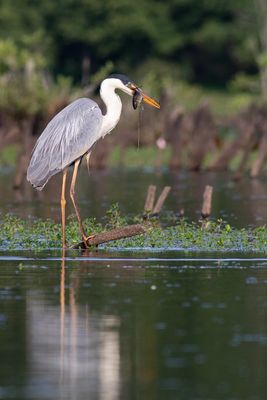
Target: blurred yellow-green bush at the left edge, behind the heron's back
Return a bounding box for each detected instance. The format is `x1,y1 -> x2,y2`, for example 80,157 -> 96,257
0,37 -> 82,119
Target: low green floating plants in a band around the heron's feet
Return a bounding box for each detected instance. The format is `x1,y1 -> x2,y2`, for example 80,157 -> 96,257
0,205 -> 267,252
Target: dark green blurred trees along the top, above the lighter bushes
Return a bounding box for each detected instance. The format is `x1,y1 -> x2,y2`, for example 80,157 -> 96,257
0,0 -> 262,87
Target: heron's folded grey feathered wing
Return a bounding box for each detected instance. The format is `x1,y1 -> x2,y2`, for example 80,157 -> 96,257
27,98 -> 103,190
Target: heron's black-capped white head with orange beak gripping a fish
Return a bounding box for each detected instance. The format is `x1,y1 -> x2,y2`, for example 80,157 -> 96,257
101,74 -> 160,108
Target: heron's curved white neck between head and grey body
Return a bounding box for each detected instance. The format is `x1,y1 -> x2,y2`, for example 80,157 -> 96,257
100,81 -> 122,136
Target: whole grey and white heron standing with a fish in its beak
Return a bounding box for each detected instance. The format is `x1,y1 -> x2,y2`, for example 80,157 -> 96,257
27,74 -> 160,248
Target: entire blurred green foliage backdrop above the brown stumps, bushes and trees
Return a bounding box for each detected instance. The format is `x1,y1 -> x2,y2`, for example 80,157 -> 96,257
0,0 -> 266,119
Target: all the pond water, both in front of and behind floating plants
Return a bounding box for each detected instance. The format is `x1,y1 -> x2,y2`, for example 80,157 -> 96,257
0,171 -> 267,400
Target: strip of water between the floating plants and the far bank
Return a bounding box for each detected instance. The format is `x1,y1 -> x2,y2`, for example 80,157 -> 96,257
0,169 -> 267,227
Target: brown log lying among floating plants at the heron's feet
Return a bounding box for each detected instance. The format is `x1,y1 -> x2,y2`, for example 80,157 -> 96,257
72,224 -> 146,249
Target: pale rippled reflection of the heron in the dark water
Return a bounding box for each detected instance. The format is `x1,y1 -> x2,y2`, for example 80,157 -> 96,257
27,252 -> 120,400
